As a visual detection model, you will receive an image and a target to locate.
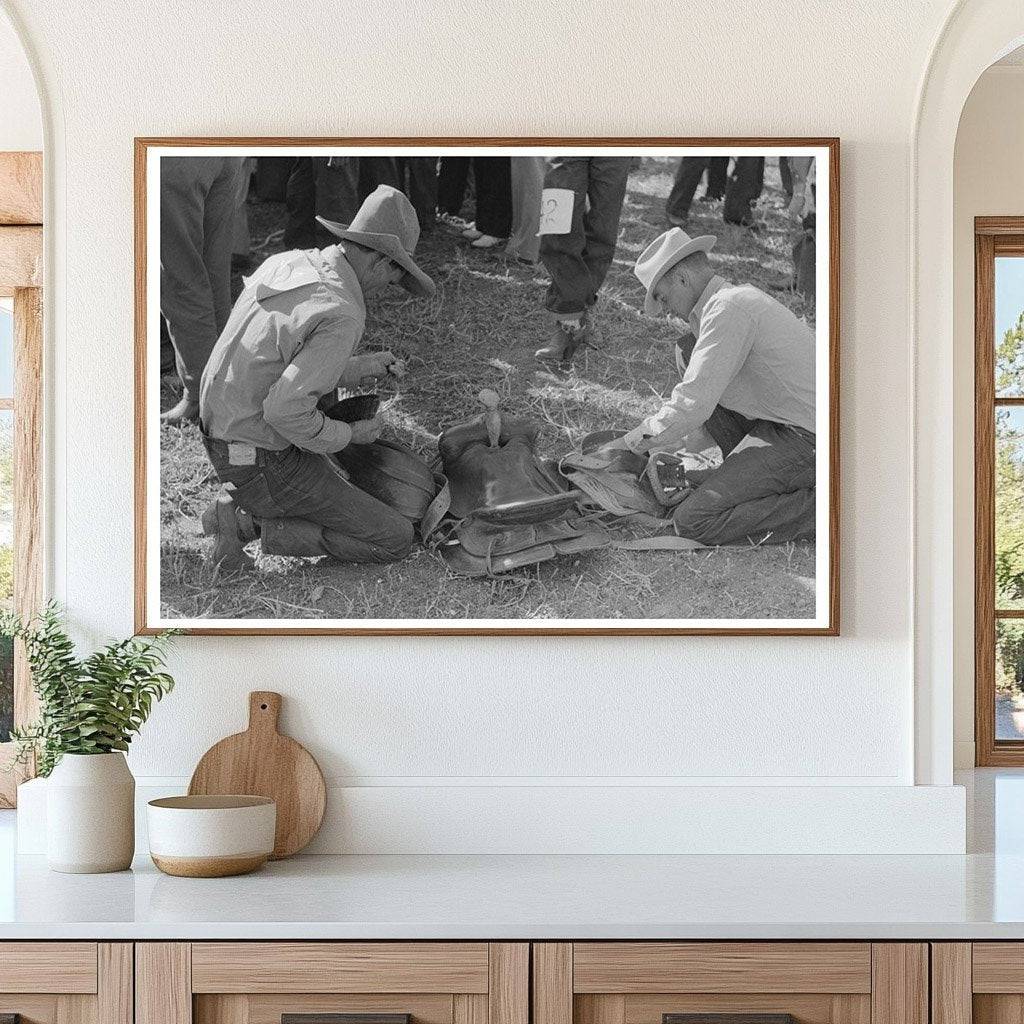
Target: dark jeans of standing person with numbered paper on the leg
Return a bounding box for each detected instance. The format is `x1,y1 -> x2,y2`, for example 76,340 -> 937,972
541,157 -> 631,315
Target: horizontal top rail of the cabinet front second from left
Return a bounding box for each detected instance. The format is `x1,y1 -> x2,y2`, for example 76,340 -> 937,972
191,942 -> 488,992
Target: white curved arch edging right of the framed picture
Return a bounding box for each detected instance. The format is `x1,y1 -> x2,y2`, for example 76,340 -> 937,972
908,0 -> 1024,785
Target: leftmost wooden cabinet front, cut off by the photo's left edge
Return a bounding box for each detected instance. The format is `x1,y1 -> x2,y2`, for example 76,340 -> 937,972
0,942 -> 132,1024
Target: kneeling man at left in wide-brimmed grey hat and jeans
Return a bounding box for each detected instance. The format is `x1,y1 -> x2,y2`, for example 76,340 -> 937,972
200,185 -> 434,569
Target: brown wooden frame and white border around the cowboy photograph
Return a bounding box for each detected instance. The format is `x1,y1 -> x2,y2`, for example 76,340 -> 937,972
134,136 -> 841,636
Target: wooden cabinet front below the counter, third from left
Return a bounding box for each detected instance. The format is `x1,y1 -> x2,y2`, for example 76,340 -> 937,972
534,942 -> 928,1024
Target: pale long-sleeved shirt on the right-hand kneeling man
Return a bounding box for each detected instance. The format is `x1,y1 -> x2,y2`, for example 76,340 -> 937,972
625,276 -> 815,452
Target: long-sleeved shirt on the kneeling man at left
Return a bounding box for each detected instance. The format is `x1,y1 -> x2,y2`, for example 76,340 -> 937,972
200,246 -> 367,453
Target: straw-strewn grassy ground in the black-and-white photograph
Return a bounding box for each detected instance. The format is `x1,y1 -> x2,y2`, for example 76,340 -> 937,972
161,159 -> 814,620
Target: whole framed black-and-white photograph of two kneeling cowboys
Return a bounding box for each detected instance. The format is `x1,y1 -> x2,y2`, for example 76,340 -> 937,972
135,138 -> 840,635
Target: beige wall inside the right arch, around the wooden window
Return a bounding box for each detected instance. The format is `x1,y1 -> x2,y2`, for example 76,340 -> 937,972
953,63 -> 1024,768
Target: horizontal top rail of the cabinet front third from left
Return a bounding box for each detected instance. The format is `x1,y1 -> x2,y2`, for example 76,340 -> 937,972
572,942 -> 871,993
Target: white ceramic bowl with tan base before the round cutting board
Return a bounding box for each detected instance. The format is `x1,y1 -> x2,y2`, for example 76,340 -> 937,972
146,794 -> 278,879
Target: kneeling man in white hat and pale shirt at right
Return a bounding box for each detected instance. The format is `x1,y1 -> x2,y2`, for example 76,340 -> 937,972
621,227 -> 815,545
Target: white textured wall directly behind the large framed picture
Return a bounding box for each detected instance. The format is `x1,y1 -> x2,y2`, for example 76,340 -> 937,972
0,0 -> 963,845
